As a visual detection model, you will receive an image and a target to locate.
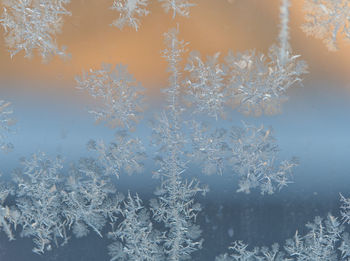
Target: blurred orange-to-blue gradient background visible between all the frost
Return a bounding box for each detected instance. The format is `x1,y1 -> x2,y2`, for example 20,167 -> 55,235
0,0 -> 350,261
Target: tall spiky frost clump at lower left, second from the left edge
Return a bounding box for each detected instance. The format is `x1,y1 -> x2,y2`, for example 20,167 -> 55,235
14,152 -> 68,254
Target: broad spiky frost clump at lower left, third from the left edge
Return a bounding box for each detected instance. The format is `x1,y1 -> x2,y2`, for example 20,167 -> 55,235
62,159 -> 122,238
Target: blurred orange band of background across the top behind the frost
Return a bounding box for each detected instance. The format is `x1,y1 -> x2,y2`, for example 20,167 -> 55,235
0,0 -> 350,96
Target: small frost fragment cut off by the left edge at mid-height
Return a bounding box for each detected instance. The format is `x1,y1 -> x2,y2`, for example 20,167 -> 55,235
0,100 -> 15,151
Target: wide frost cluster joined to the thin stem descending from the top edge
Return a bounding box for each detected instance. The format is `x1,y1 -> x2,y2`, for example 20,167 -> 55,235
185,1 -> 307,119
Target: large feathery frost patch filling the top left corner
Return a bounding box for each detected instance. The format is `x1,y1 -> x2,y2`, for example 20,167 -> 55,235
0,0 -> 70,61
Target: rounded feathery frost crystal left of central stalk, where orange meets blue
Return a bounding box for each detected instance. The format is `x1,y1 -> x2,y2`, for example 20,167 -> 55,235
76,64 -> 142,128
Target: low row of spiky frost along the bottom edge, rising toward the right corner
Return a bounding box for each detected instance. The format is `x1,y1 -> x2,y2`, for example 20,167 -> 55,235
216,214 -> 350,261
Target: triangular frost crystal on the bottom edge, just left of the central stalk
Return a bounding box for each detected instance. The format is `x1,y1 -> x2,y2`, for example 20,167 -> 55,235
108,192 -> 163,261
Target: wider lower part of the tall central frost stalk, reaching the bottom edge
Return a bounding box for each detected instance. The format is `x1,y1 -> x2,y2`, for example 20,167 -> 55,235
151,114 -> 208,260
